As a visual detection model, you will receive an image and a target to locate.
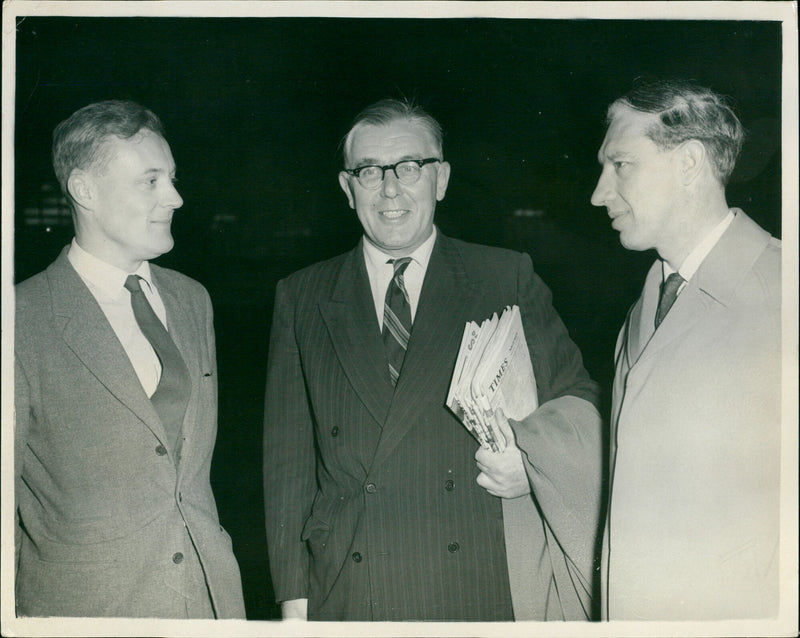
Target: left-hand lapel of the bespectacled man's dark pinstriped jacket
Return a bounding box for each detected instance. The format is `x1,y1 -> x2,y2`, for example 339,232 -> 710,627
320,245 -> 392,425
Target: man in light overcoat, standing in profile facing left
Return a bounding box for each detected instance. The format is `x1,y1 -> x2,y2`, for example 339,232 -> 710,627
592,81 -> 781,620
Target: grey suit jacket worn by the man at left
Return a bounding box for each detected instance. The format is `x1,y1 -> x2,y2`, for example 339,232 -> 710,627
14,249 -> 244,617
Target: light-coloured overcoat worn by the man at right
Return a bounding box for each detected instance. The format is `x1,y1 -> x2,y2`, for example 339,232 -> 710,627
602,210 -> 781,620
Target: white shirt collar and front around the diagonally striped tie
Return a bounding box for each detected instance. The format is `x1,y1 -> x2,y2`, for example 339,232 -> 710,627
362,226 -> 436,330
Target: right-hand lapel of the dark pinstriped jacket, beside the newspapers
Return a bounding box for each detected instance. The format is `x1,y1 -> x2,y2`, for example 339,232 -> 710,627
373,234 -> 475,465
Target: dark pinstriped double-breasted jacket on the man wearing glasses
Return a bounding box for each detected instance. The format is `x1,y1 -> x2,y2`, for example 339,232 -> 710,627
264,233 -> 596,621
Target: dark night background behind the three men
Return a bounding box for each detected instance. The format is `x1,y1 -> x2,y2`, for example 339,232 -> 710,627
14,17 -> 781,619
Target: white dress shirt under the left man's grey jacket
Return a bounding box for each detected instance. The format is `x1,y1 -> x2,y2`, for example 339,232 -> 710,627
67,239 -> 167,397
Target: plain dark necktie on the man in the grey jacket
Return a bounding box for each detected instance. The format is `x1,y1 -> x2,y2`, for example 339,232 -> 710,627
125,275 -> 191,458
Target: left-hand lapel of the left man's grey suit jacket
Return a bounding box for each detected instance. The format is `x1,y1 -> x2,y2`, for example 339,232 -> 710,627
47,249 -> 167,443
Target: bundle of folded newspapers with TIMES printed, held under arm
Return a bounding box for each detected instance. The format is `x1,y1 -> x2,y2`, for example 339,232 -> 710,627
447,306 -> 538,452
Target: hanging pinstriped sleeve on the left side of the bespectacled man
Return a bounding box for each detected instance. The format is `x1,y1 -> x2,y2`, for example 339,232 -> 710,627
264,281 -> 316,602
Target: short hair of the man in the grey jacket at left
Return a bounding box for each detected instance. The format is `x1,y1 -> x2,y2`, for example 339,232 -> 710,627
53,100 -> 164,197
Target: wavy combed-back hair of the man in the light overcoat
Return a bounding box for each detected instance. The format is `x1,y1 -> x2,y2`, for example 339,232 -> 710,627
607,80 -> 744,185
